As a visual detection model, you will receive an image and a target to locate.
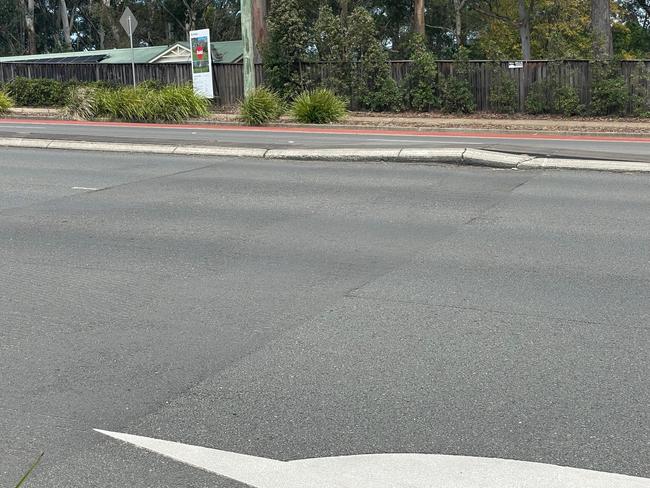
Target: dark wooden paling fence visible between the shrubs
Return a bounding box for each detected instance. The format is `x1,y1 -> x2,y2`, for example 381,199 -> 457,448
0,60 -> 650,111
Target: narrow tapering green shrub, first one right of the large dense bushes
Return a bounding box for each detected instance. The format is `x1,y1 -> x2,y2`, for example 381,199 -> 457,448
402,34 -> 440,112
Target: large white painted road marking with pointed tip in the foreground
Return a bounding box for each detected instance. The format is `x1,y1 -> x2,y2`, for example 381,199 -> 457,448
95,429 -> 650,488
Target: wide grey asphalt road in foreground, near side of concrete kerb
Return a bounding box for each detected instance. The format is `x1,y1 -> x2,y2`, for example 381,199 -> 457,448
0,148 -> 650,488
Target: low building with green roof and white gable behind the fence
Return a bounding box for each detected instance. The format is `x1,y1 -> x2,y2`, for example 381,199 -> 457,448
0,40 -> 244,64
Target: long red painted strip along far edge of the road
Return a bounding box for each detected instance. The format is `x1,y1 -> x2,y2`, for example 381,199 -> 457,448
0,119 -> 650,144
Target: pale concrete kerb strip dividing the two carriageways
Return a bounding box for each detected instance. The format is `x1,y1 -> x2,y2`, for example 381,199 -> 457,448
0,138 -> 650,173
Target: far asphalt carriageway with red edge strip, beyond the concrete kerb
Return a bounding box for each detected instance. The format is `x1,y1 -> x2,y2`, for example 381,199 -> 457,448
0,120 -> 650,162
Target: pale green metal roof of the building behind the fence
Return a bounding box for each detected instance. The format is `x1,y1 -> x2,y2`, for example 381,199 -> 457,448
0,41 -> 244,64
